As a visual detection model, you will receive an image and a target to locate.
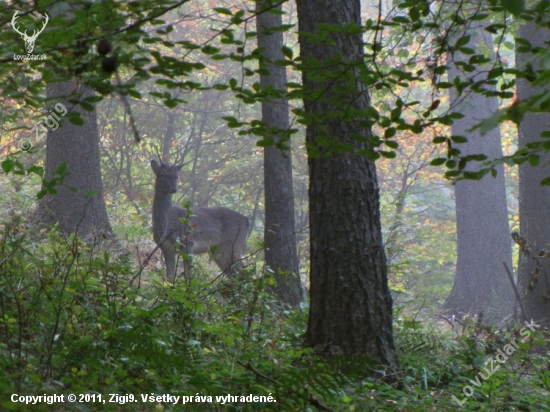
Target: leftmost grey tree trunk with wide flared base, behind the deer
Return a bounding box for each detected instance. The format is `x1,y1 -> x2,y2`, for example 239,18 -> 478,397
15,2 -> 113,242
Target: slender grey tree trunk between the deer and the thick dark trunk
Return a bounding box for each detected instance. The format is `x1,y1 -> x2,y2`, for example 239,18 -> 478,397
256,0 -> 302,307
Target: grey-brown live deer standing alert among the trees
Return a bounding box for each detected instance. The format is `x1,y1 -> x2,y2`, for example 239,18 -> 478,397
151,160 -> 250,283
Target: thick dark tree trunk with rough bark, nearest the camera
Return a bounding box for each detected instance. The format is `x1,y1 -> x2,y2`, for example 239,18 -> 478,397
297,0 -> 398,367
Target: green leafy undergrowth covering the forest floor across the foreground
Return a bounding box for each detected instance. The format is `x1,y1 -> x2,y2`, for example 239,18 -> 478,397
0,219 -> 550,411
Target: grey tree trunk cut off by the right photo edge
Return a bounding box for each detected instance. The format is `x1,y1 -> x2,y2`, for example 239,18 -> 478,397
516,22 -> 550,328
